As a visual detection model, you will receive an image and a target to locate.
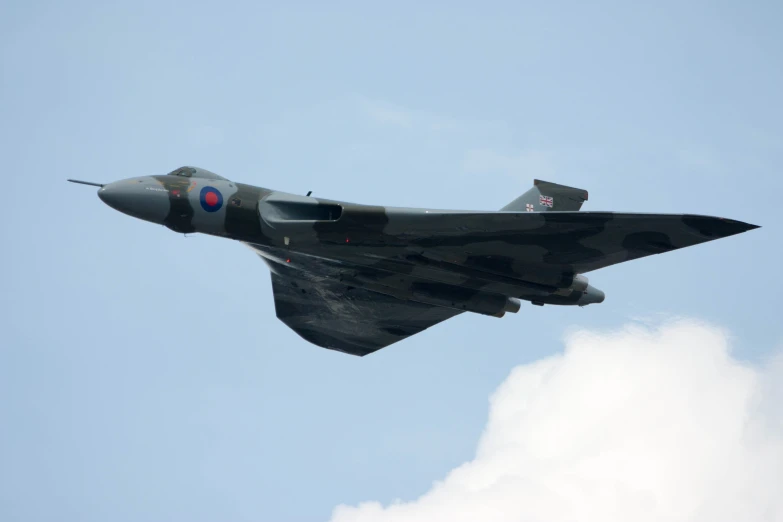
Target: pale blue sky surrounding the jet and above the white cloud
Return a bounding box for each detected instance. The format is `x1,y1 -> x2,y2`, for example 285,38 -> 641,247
0,0 -> 783,521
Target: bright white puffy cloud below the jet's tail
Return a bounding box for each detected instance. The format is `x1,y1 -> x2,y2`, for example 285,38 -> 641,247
332,321 -> 783,522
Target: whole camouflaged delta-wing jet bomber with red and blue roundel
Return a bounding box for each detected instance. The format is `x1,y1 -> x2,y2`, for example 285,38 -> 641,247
68,167 -> 758,356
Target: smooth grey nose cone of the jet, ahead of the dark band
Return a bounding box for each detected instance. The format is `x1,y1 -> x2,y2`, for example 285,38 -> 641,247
98,178 -> 169,223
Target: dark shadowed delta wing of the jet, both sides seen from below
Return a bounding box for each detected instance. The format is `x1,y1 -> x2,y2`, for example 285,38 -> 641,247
251,206 -> 757,355
